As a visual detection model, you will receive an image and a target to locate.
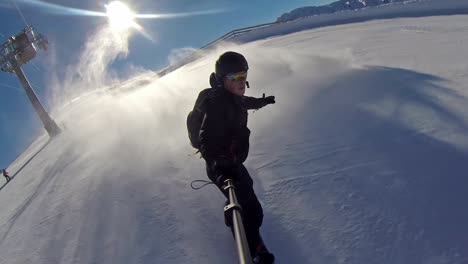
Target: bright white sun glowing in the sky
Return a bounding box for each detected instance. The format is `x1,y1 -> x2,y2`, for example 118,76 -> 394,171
105,1 -> 136,31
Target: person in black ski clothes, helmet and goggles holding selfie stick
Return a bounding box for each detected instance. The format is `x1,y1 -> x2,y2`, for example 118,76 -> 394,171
187,51 -> 275,264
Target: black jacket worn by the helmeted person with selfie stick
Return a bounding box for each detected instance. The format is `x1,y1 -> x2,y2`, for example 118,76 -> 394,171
197,88 -> 266,163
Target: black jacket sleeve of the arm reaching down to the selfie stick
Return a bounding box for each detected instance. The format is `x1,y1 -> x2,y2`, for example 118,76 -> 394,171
200,98 -> 227,163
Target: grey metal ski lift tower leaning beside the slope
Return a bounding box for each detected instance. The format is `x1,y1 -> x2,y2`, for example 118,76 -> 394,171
0,26 -> 61,137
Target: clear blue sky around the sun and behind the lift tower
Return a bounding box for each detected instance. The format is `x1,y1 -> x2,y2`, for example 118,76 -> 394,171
0,0 -> 334,167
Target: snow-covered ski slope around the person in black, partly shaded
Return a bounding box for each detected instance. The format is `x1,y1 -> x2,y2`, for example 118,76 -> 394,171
0,12 -> 468,264
